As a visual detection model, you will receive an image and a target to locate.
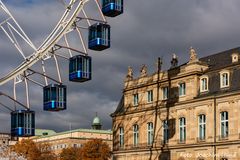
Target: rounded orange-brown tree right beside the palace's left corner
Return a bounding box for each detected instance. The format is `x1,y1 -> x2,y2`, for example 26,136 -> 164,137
81,139 -> 111,160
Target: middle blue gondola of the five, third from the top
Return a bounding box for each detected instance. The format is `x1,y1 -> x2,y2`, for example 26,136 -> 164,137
69,55 -> 92,82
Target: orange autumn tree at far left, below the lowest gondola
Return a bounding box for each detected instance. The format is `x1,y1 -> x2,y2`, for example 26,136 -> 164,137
13,139 -> 56,160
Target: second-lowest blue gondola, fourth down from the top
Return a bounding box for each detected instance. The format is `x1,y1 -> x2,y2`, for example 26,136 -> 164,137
43,84 -> 67,111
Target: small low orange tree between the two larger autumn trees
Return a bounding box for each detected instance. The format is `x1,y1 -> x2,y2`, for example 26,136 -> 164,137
60,147 -> 81,160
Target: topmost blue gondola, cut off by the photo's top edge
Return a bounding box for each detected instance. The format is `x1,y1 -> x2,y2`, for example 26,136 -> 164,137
102,0 -> 123,17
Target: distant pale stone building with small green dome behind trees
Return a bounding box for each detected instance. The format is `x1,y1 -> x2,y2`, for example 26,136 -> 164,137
31,115 -> 112,155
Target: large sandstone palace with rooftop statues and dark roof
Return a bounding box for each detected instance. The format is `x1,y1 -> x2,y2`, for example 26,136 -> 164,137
111,48 -> 240,160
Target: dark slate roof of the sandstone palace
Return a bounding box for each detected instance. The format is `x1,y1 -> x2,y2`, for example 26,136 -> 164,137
111,47 -> 240,117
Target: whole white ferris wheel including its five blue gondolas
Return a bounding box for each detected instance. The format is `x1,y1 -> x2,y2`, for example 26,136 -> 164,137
0,0 -> 123,136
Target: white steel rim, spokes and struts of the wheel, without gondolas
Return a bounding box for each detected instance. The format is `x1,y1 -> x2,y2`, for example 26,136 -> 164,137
0,0 -> 110,109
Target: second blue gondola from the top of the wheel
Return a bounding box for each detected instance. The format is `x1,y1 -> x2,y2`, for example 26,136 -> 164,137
88,23 -> 110,51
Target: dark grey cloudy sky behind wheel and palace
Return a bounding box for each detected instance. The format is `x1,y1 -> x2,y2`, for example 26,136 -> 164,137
0,0 -> 240,132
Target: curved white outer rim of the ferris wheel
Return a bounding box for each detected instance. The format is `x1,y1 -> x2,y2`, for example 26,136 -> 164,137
0,0 -> 88,85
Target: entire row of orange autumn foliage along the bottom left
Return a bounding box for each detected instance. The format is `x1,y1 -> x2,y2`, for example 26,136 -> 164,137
12,139 -> 111,160
